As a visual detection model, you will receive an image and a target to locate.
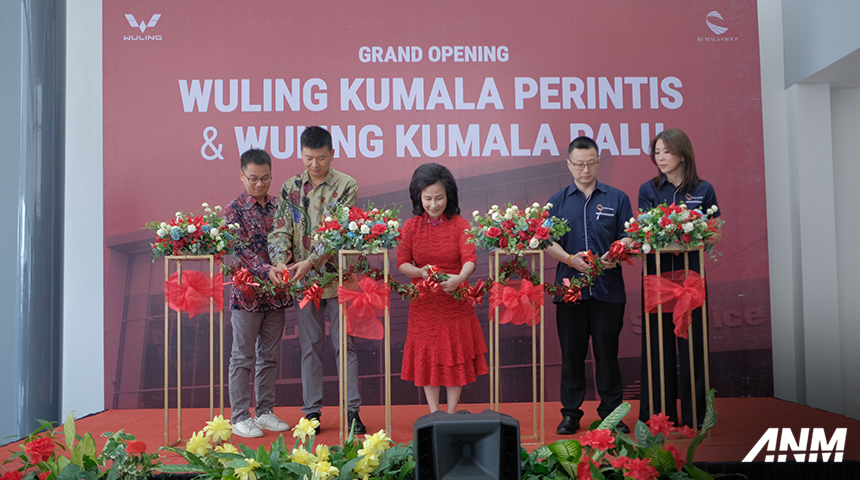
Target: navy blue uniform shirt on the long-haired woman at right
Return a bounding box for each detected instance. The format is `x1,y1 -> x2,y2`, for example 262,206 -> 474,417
640,174 -> 720,273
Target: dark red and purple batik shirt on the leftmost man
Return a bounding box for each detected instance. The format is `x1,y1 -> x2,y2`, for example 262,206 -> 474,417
224,191 -> 293,312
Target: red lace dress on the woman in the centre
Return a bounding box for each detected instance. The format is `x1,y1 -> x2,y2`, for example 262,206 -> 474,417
397,213 -> 488,387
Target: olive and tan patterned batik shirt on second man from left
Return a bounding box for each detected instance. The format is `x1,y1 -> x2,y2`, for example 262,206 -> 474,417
269,167 -> 358,298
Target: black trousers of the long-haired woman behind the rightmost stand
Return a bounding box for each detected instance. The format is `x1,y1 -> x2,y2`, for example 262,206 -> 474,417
639,305 -> 705,427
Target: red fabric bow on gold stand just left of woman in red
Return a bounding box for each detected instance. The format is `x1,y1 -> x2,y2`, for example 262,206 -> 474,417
337,277 -> 389,340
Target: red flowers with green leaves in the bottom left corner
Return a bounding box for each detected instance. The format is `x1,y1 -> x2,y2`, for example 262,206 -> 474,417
2,414 -> 161,480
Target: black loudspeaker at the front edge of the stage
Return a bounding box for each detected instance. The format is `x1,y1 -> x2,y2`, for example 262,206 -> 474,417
412,410 -> 520,480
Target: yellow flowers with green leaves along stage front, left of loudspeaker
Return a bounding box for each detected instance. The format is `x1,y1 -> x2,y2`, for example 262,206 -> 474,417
159,415 -> 415,480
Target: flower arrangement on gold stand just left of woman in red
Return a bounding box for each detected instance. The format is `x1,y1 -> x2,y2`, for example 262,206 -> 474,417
314,205 -> 400,253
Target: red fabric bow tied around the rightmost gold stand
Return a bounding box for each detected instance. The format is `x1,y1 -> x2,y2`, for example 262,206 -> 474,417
642,272 -> 705,338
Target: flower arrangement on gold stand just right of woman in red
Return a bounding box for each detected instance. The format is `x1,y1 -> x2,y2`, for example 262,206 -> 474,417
468,203 -> 570,255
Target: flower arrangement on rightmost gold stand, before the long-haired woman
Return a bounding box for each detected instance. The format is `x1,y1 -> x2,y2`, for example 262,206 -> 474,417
624,203 -> 725,255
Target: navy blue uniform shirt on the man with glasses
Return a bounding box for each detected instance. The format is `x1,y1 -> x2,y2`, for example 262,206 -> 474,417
549,182 -> 633,303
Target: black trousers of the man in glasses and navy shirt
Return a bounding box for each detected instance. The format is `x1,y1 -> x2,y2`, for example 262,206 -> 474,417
556,298 -> 624,420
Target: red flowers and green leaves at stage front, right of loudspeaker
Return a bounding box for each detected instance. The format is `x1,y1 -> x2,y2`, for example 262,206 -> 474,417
520,389 -> 717,480
